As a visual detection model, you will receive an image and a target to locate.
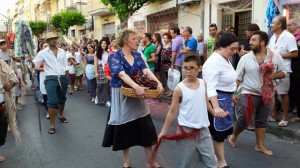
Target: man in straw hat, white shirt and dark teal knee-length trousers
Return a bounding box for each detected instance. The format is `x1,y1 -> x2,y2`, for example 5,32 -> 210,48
33,32 -> 69,134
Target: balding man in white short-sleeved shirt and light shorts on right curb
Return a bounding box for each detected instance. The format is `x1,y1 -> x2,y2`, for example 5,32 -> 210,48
269,16 -> 298,127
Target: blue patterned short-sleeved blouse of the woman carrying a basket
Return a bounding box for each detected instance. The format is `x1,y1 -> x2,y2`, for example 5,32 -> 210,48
109,50 -> 147,88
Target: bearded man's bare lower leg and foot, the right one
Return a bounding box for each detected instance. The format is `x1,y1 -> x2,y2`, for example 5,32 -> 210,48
255,128 -> 273,156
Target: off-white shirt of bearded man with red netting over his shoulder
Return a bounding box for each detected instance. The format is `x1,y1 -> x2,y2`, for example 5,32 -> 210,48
236,51 -> 284,96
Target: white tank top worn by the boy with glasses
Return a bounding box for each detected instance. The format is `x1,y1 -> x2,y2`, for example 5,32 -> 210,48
178,79 -> 210,129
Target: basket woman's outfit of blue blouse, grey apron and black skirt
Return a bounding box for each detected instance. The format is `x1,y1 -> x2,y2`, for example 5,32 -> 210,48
102,50 -> 157,151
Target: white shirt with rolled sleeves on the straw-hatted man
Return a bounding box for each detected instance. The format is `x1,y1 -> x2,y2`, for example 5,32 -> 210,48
33,47 -> 68,76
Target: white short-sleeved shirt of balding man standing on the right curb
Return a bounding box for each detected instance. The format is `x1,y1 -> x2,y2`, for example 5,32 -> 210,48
269,30 -> 298,72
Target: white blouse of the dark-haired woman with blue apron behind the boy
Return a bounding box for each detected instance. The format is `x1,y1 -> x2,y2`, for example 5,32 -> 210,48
203,52 -> 237,97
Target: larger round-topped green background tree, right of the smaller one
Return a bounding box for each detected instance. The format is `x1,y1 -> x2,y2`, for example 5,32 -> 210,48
50,10 -> 85,35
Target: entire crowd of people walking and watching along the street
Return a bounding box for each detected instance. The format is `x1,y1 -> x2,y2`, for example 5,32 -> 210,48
0,16 -> 300,168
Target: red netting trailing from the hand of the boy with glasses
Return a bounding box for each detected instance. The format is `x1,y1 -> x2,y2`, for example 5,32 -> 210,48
149,125 -> 200,163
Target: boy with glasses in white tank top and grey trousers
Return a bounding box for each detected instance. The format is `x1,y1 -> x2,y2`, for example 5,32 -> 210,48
158,54 -> 227,168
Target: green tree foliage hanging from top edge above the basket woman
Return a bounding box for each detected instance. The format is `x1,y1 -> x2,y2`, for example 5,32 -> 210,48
101,0 -> 155,24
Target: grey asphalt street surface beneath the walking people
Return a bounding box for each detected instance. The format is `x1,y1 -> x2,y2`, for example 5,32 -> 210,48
0,86 -> 300,168
